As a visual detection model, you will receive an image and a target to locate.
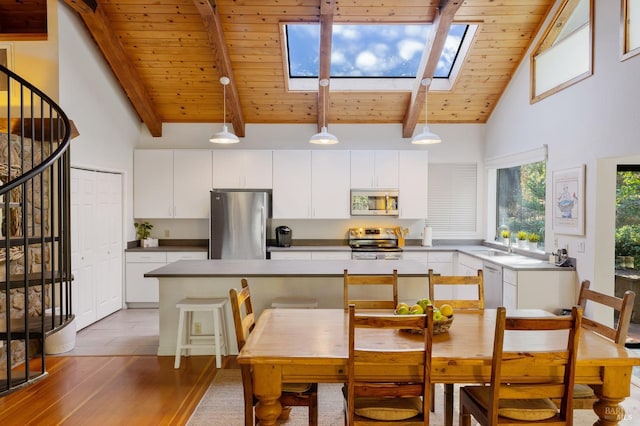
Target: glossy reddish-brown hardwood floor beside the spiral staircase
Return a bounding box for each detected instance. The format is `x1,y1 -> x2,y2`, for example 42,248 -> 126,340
0,355 -> 228,426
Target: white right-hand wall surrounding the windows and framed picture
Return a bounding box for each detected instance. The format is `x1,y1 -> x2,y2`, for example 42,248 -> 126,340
485,0 -> 640,300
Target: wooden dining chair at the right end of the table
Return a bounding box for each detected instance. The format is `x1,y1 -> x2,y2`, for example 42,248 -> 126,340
573,280 -> 636,409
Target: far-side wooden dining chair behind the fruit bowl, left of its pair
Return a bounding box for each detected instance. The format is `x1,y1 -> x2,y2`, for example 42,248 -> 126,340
344,269 -> 398,311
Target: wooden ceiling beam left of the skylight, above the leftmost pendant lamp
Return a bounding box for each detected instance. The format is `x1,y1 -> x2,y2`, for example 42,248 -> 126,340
193,0 -> 245,138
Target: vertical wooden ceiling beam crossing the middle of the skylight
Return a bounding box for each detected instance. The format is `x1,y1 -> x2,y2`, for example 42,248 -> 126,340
318,0 -> 336,131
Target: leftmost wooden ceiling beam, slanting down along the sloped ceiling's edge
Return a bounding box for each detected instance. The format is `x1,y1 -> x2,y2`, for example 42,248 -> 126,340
64,0 -> 162,137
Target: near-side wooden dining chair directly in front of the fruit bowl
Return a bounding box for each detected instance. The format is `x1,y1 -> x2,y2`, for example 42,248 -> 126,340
343,304 -> 433,426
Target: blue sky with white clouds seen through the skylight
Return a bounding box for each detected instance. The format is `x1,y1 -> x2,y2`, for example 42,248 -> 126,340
287,24 -> 467,78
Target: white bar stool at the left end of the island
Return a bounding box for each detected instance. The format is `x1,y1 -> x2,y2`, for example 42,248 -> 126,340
173,298 -> 228,368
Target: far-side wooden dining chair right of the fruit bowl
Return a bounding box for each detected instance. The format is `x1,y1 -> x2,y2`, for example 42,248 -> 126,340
429,269 -> 484,426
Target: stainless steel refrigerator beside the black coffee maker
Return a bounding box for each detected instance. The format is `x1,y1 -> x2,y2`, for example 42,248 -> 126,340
209,190 -> 271,259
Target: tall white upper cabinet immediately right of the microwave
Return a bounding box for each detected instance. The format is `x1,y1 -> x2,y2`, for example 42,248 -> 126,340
398,151 -> 429,219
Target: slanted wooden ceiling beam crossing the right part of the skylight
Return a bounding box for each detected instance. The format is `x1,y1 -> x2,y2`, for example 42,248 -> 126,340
402,0 -> 463,138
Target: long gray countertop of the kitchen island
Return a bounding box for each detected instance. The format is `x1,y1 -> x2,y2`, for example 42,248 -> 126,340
144,259 -> 427,278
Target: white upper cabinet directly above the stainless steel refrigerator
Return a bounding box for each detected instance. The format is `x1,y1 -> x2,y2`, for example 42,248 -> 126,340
213,149 -> 273,189
